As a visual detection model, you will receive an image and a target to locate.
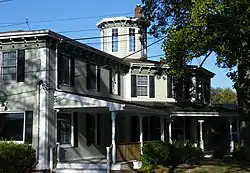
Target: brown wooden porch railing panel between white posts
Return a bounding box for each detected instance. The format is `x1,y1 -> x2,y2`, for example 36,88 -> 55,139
117,142 -> 141,161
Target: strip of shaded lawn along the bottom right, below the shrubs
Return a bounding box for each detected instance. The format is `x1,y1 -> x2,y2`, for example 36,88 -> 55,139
139,159 -> 250,173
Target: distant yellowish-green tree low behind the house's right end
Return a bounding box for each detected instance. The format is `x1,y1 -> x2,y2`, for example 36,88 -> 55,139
211,88 -> 237,104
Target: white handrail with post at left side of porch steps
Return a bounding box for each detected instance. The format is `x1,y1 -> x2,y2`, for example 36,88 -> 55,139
49,143 -> 60,173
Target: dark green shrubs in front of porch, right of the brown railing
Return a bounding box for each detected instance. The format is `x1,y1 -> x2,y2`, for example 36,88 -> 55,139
140,141 -> 203,169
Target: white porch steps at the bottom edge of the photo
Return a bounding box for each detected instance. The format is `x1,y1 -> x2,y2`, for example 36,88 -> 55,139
54,163 -> 107,173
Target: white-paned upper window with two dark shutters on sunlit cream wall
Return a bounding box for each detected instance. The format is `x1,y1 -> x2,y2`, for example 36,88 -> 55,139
131,75 -> 155,98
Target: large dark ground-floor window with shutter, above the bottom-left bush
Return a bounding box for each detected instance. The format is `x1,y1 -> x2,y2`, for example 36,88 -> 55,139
0,111 -> 33,144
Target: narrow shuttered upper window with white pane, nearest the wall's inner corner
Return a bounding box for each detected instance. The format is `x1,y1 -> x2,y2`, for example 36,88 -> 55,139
109,70 -> 121,95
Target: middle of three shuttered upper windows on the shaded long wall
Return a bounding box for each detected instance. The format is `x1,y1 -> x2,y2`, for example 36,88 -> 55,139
87,64 -> 100,91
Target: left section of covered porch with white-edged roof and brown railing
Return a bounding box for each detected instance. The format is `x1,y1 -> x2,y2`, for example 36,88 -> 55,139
54,93 -> 169,169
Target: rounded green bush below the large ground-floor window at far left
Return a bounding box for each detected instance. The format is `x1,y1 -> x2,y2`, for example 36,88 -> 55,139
0,142 -> 36,173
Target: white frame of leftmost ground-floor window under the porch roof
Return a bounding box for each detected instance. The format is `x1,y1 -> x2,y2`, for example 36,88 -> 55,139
55,112 -> 75,148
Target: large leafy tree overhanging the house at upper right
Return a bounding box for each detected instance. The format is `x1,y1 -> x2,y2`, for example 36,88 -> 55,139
142,0 -> 250,144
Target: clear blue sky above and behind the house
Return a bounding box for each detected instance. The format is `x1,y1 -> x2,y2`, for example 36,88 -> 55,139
0,0 -> 232,87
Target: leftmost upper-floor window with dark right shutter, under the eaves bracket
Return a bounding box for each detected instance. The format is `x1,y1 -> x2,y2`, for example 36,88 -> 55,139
0,50 -> 25,82
